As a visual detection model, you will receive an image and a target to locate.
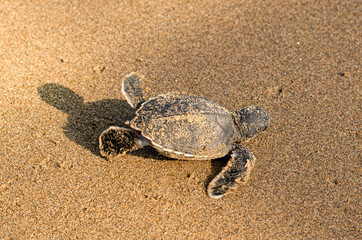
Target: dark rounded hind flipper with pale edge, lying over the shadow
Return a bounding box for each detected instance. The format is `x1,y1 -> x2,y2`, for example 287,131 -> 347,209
99,126 -> 149,159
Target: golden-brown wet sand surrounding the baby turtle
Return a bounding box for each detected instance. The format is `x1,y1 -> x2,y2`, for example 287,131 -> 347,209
0,0 -> 362,239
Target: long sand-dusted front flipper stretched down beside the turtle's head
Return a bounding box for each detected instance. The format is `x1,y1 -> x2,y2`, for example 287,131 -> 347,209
207,145 -> 255,198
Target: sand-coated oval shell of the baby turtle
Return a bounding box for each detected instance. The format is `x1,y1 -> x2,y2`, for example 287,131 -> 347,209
130,93 -> 237,160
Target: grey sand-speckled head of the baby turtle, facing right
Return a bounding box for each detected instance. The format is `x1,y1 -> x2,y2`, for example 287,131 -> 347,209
235,106 -> 271,140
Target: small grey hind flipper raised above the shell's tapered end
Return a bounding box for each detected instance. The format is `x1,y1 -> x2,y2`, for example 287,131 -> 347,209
122,73 -> 145,108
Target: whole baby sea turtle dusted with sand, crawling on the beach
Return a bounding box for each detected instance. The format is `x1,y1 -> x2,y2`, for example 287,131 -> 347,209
99,73 -> 271,198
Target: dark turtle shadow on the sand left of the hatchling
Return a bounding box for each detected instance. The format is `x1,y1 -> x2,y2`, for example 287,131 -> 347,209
38,83 -> 135,156
